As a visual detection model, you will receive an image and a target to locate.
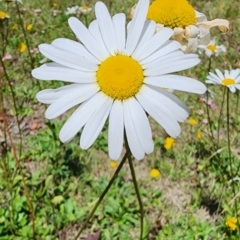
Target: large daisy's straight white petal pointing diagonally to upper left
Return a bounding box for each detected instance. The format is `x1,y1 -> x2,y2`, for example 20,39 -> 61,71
68,17 -> 107,61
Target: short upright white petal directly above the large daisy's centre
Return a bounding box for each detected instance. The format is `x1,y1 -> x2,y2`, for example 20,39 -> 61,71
113,13 -> 126,52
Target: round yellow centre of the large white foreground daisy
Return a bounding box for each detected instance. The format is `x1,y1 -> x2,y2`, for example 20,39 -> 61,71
96,55 -> 144,100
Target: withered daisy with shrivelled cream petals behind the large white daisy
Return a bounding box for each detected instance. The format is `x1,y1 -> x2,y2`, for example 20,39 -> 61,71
131,0 -> 229,53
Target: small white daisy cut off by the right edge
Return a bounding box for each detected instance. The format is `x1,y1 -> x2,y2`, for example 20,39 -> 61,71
206,68 -> 240,92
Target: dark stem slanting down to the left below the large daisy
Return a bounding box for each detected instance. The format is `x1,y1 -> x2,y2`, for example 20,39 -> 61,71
74,148 -> 131,240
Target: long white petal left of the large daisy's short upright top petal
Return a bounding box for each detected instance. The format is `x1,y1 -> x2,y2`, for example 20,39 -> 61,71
95,2 -> 117,55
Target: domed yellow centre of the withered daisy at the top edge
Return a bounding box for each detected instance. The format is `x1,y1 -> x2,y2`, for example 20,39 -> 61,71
147,0 -> 197,29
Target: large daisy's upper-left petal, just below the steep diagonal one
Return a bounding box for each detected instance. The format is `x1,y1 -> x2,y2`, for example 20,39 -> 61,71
52,38 -> 100,64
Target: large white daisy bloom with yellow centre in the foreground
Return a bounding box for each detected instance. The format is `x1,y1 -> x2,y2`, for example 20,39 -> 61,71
32,0 -> 206,160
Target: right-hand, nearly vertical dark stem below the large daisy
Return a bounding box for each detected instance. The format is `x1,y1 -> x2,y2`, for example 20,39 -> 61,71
128,155 -> 144,240
